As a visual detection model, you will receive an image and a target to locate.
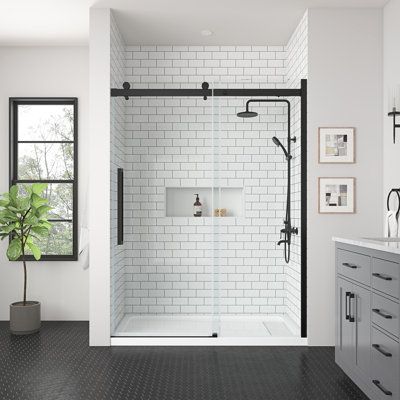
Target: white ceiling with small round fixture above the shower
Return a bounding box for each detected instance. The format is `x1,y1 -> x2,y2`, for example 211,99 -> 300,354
0,0 -> 388,45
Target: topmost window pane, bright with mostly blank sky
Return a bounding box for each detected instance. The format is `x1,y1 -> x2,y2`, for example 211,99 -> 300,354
18,104 -> 74,141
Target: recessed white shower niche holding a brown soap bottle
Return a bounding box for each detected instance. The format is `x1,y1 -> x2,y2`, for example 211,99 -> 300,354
165,187 -> 244,218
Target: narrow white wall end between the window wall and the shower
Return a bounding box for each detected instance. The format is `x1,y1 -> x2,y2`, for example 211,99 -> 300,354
88,8 -> 111,346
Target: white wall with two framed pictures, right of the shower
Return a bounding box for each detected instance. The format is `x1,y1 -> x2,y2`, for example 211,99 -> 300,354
307,9 -> 383,345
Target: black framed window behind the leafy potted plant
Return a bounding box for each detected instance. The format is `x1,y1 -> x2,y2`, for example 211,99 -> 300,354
10,97 -> 78,261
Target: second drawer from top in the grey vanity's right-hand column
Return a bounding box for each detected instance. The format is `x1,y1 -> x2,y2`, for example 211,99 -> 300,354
371,293 -> 399,337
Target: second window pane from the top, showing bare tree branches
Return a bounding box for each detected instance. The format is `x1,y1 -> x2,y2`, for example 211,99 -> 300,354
18,143 -> 74,180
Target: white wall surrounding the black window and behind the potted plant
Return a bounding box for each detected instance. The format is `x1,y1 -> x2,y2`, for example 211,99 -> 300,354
0,47 -> 89,320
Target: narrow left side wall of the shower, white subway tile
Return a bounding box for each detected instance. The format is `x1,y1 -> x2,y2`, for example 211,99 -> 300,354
110,12 -> 125,332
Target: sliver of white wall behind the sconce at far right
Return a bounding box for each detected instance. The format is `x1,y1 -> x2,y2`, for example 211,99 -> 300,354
382,0 -> 400,222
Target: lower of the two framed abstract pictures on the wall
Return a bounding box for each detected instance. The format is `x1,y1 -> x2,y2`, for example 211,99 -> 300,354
318,177 -> 356,214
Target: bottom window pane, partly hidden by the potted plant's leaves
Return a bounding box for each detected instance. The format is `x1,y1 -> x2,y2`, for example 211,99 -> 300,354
30,222 -> 72,256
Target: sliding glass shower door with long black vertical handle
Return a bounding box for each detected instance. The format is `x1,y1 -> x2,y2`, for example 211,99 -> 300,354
111,87 -> 220,337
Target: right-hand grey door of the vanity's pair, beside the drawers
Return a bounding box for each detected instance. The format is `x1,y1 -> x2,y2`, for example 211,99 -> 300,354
351,285 -> 371,376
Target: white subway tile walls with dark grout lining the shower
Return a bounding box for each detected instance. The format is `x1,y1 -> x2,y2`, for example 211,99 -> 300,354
111,14 -> 306,330
